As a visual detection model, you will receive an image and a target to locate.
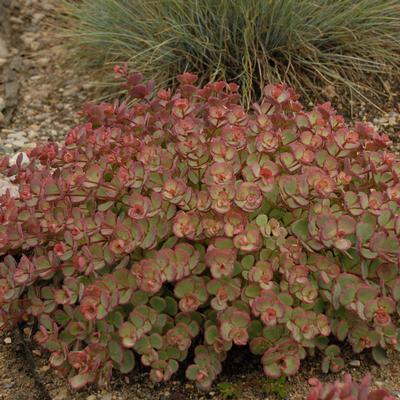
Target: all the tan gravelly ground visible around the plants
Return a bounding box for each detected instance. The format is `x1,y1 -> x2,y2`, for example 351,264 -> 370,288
0,0 -> 400,400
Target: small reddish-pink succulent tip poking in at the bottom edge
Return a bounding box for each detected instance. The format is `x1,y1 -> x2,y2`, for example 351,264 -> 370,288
307,374 -> 395,400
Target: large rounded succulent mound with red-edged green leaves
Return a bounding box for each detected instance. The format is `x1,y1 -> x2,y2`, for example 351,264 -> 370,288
0,68 -> 400,389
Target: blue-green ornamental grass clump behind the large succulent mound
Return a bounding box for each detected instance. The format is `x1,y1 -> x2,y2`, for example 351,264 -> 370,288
60,0 -> 400,106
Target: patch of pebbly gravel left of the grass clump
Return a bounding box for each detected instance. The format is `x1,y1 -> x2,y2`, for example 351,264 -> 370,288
0,0 -> 92,154
